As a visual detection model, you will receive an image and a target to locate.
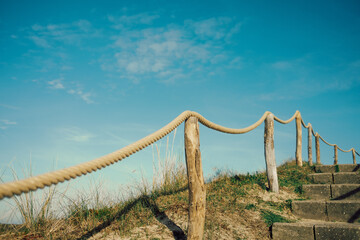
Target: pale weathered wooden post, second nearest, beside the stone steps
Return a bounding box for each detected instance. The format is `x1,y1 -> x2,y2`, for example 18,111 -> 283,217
264,114 -> 279,193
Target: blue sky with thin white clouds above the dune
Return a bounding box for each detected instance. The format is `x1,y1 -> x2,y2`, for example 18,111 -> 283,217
0,0 -> 360,223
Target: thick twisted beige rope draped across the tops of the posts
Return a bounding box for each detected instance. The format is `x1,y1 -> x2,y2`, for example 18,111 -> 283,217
0,111 -> 360,200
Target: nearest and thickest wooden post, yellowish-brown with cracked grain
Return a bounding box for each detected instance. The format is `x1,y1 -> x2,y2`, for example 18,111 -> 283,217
185,117 -> 206,240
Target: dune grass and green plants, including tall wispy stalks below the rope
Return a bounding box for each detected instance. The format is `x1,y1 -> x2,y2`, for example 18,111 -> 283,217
0,140 -> 313,240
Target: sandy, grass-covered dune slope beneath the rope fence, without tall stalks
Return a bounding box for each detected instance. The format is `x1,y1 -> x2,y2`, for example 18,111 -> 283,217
0,161 -> 312,240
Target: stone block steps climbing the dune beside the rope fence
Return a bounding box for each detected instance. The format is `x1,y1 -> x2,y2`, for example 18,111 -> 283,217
272,164 -> 360,240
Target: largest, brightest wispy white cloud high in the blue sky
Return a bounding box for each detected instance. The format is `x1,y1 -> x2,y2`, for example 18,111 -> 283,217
102,14 -> 240,83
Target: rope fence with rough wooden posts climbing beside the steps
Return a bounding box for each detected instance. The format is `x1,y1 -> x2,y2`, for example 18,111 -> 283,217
0,111 -> 360,239
